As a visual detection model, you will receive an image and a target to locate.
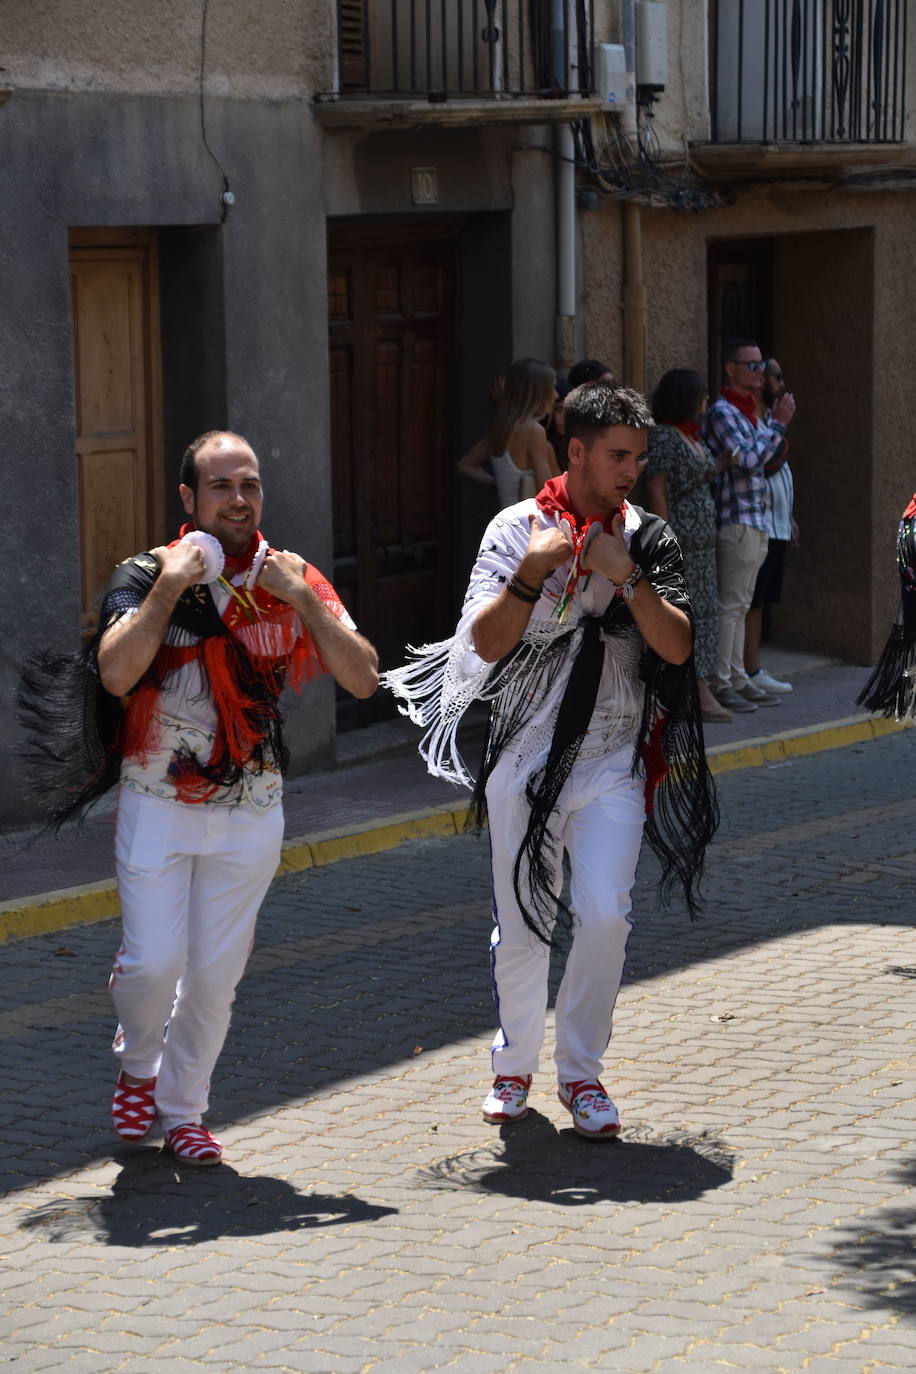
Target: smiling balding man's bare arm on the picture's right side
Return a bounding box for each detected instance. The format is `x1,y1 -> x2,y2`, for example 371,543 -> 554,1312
258,550 -> 379,698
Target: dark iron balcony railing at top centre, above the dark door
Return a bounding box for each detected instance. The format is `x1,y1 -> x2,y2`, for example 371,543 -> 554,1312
336,0 -> 593,100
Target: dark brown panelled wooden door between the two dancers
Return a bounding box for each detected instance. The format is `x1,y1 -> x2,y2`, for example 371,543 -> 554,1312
328,219 -> 456,728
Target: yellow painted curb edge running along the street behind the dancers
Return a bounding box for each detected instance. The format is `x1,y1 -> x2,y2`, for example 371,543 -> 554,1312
0,716 -> 905,944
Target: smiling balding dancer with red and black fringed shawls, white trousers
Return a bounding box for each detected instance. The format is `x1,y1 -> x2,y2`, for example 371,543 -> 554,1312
21,431 -> 378,1165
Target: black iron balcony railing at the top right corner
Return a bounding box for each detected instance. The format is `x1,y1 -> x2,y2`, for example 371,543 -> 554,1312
713,0 -> 908,143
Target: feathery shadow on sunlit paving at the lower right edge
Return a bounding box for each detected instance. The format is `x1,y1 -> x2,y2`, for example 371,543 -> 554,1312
831,1160 -> 916,1320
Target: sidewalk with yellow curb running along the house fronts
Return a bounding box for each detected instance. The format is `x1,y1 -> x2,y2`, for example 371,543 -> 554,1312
0,651 -> 898,941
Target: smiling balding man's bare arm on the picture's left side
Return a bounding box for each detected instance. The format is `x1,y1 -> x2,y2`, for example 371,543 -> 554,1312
99,543 -> 205,697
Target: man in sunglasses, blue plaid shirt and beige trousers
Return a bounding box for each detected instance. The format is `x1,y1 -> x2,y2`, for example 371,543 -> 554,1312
703,339 -> 795,712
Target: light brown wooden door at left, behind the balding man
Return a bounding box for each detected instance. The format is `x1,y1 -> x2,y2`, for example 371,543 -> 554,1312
70,229 -> 163,639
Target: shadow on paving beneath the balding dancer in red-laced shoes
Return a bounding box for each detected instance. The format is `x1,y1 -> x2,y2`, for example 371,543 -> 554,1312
14,1149 -> 397,1248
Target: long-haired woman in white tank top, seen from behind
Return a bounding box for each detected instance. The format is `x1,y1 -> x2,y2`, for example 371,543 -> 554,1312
457,357 -> 560,510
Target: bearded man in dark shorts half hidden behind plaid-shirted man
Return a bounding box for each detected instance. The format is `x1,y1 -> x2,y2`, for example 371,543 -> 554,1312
744,357 -> 798,697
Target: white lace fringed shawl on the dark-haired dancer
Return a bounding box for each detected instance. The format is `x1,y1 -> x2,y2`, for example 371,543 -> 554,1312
382,499 -> 643,787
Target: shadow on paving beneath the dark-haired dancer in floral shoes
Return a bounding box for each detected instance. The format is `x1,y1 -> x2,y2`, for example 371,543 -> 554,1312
417,1110 -> 733,1206
